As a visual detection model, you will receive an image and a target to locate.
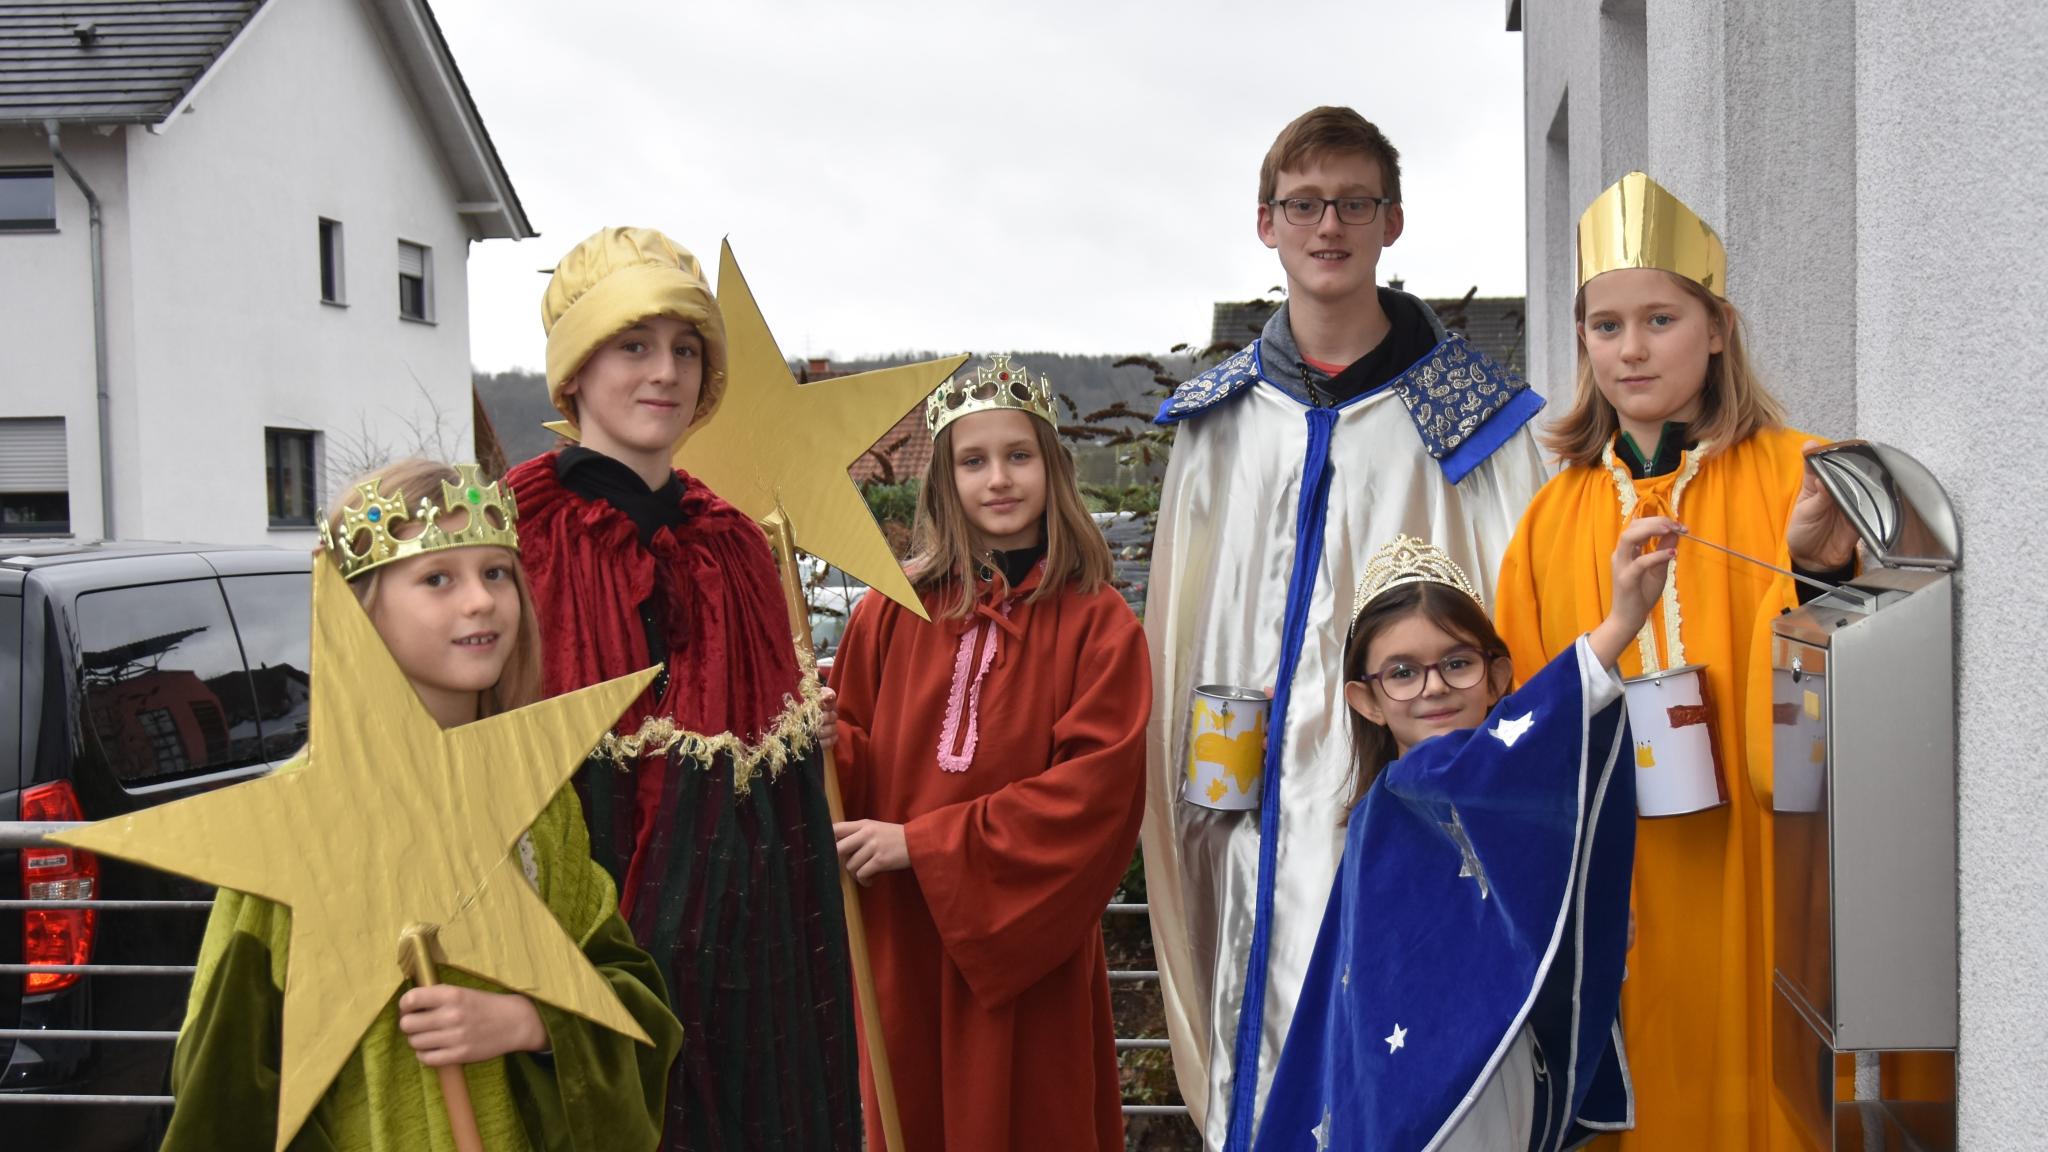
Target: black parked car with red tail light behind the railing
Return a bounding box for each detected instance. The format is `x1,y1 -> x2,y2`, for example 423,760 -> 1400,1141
0,541 -> 309,1152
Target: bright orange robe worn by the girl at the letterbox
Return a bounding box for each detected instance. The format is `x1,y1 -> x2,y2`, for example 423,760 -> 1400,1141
1495,428 -> 1812,1152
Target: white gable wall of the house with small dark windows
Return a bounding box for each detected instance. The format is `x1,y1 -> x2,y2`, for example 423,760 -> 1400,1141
115,0 -> 471,545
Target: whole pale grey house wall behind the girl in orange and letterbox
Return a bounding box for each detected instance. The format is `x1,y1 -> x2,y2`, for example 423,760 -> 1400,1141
1522,0 -> 2048,1150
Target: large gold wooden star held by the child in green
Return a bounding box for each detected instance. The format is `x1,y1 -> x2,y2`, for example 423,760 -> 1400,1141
55,560 -> 653,1152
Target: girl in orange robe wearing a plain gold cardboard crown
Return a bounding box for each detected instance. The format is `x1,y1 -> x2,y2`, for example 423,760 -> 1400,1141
1497,172 -> 1855,1152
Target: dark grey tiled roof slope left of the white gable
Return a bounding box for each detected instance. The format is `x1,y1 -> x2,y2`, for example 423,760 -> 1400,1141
0,0 -> 262,125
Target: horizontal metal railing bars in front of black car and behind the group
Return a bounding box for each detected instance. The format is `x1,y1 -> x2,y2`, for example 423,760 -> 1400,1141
0,820 -> 1188,1115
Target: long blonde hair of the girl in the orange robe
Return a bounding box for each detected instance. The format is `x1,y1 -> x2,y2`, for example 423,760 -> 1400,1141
1538,273 -> 1786,467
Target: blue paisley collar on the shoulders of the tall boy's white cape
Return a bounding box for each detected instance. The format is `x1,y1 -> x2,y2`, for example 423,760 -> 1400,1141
1153,334 -> 1544,484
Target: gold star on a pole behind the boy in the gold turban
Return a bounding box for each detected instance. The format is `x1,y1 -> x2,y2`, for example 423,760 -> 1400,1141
547,244 -> 967,619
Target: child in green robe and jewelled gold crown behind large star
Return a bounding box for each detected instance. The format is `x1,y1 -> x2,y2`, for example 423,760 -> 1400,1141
164,461 -> 682,1152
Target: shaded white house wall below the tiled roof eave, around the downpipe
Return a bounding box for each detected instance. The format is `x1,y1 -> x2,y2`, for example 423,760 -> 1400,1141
0,127 -> 129,539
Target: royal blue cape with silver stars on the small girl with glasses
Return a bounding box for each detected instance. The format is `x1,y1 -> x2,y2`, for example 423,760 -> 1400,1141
1257,642 -> 1636,1152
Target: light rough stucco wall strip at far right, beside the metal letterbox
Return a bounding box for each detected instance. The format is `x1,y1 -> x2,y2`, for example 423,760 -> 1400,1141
1853,0 -> 2048,1150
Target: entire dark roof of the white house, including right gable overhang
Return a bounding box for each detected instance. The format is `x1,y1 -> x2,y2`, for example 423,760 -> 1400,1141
0,0 -> 537,240
